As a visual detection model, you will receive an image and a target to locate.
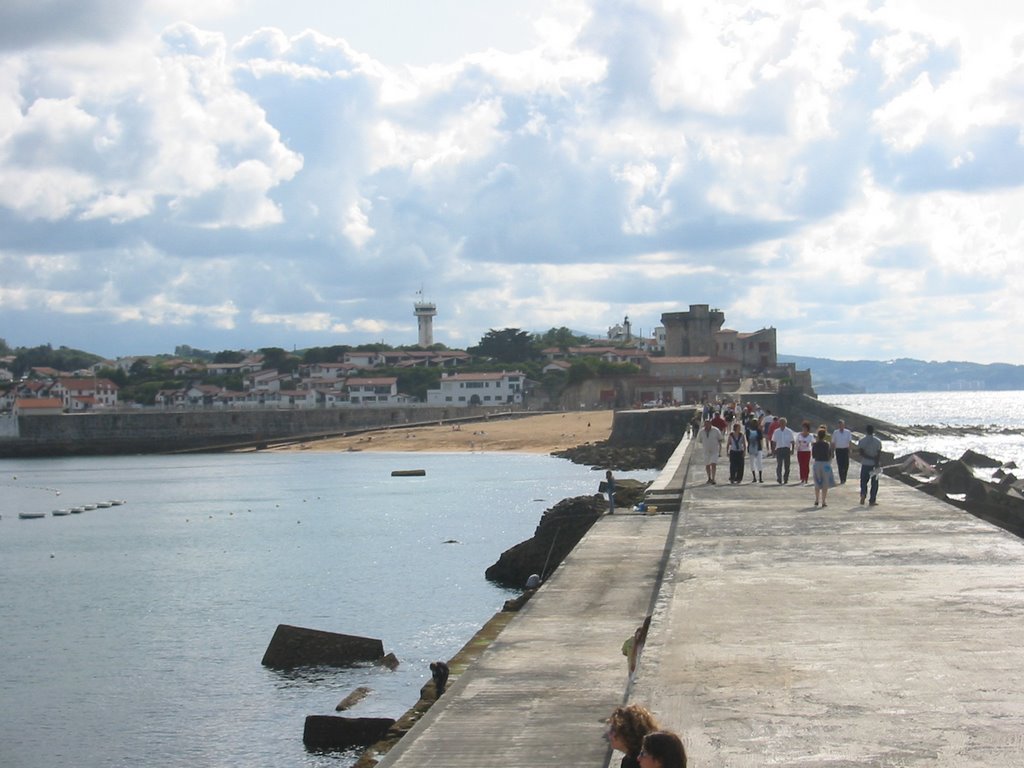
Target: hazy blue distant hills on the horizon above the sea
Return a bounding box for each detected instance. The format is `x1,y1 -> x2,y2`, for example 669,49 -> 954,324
778,354 -> 1024,394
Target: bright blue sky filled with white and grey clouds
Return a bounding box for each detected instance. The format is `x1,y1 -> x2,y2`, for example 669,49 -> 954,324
0,0 -> 1024,365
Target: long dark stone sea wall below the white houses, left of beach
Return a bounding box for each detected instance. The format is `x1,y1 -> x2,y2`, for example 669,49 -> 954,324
0,407 -> 499,458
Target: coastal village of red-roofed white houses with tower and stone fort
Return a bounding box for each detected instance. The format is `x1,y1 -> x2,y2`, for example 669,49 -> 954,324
0,301 -> 812,417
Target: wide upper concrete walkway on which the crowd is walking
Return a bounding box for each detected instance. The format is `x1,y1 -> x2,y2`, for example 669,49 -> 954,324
632,463 -> 1024,768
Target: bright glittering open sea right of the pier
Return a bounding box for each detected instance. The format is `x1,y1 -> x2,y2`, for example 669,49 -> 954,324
821,391 -> 1024,468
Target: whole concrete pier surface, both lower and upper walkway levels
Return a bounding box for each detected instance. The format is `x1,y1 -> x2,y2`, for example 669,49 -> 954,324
381,455 -> 1024,768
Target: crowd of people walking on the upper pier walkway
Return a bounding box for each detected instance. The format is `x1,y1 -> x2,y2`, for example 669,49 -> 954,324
695,403 -> 882,507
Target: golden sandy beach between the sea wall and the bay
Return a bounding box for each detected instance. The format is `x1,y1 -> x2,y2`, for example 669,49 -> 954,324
275,411 -> 613,454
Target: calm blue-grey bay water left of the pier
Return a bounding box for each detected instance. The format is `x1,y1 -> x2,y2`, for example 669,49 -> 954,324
0,452 -> 655,768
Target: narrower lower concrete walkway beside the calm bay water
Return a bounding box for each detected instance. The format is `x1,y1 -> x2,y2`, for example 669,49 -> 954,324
379,512 -> 674,768
